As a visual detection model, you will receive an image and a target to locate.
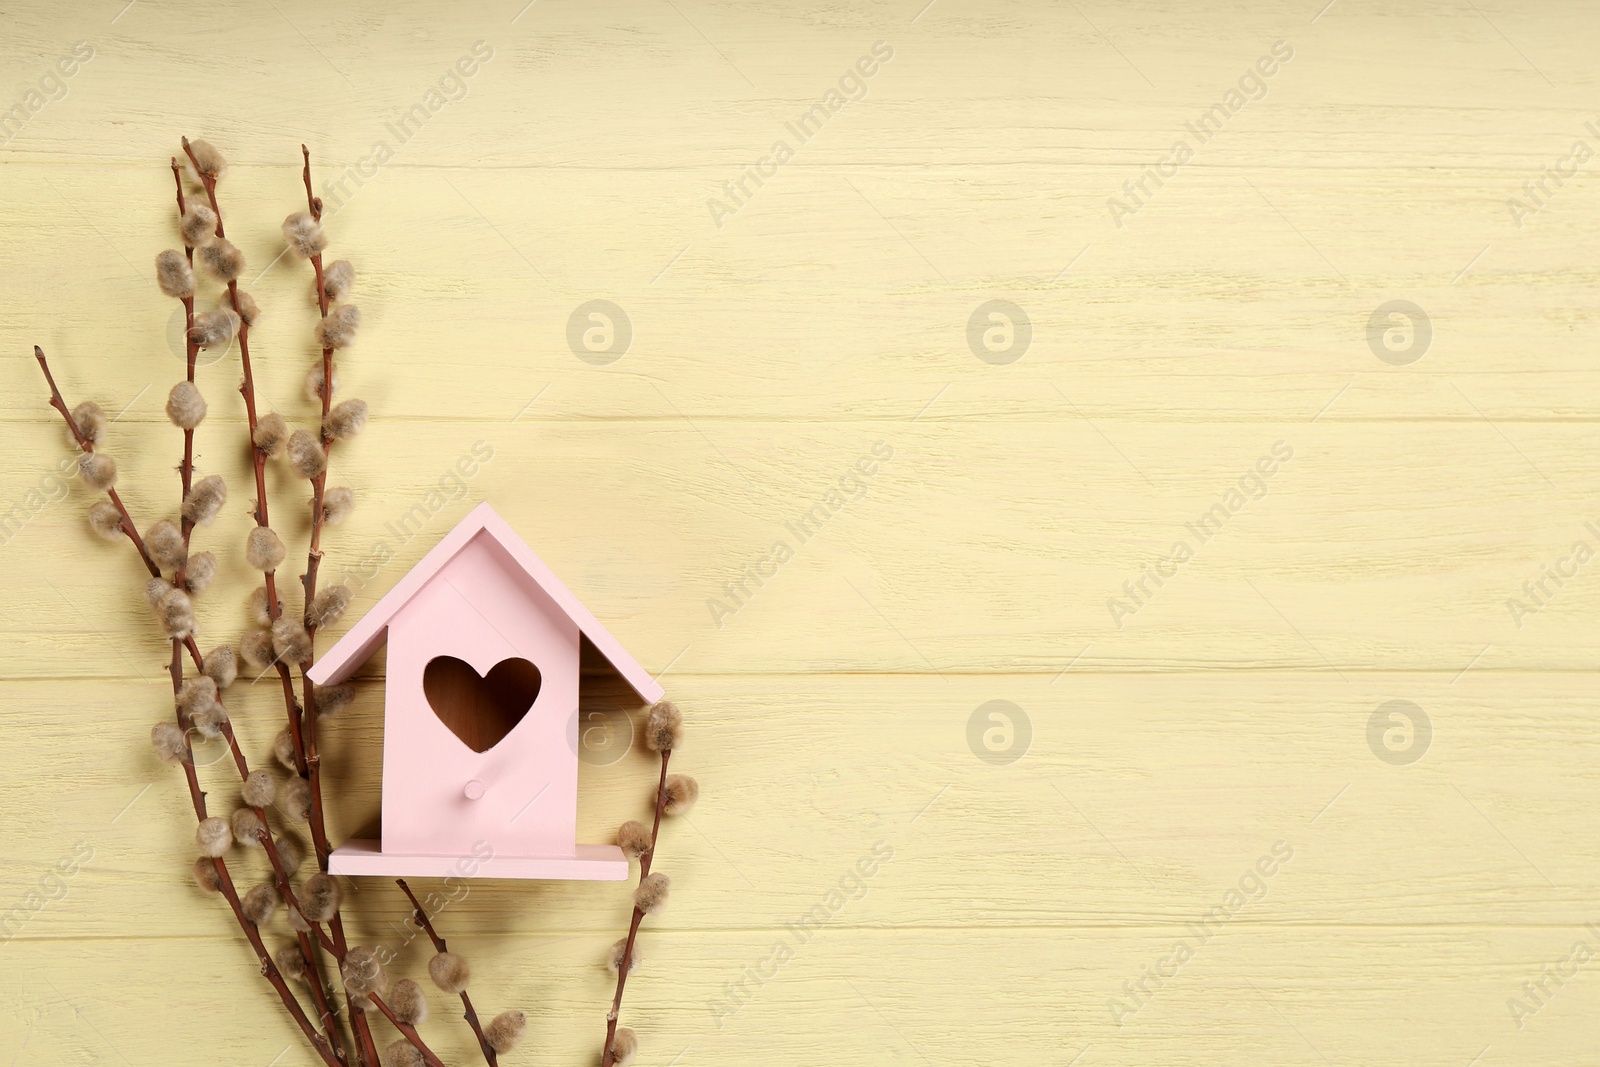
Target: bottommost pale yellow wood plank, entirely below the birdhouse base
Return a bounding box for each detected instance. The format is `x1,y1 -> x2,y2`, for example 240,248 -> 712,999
0,926 -> 1600,1067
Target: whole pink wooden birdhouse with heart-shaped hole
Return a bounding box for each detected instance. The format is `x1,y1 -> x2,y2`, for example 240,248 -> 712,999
310,504 -> 662,881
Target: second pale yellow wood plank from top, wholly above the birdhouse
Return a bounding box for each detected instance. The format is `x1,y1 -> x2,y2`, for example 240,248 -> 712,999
0,159 -> 1600,426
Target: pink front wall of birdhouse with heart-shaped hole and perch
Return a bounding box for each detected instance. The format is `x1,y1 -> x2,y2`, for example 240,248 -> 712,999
382,533 -> 579,857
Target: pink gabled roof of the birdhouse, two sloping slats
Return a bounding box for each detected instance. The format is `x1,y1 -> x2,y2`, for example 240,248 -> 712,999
307,502 -> 662,704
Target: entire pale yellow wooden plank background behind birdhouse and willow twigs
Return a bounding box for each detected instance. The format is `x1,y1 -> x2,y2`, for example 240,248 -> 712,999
0,0 -> 1600,1067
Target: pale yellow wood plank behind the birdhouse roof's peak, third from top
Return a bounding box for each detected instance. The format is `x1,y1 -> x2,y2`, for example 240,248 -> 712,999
0,419 -> 1600,685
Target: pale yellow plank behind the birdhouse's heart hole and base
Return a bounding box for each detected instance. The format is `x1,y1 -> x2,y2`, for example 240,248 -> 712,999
0,670 -> 1600,937
